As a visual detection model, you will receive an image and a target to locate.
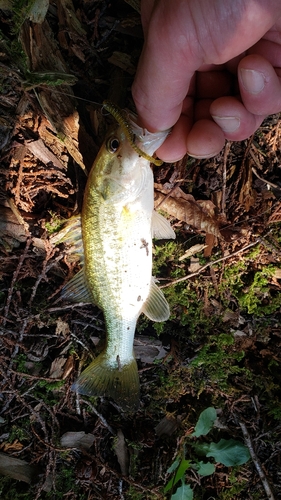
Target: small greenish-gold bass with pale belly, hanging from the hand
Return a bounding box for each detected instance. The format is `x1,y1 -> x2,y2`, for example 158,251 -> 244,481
62,107 -> 175,412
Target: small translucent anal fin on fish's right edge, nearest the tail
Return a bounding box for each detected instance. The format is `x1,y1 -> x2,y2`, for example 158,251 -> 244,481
142,279 -> 170,321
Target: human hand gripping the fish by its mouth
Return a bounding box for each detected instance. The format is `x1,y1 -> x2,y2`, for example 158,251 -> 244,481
132,0 -> 281,162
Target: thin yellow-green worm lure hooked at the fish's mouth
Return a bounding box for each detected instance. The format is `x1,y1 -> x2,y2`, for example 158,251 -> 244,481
103,101 -> 163,167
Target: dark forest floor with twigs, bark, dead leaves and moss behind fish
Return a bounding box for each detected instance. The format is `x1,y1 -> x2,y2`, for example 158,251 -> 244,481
0,0 -> 281,500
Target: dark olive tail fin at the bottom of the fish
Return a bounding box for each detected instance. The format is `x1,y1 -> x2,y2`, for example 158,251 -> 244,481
72,353 -> 140,412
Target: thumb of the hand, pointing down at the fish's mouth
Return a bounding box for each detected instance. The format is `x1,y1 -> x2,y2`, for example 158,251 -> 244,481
132,1 -> 197,131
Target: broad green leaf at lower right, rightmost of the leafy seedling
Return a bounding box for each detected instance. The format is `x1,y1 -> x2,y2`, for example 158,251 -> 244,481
206,439 -> 250,467
